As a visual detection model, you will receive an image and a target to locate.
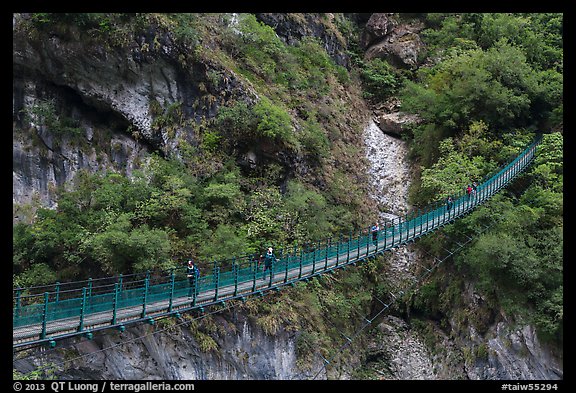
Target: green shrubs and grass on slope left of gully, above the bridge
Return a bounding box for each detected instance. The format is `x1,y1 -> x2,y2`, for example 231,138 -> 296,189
13,14 -> 374,286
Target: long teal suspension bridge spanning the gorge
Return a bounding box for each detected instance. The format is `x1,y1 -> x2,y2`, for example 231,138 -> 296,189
12,135 -> 541,349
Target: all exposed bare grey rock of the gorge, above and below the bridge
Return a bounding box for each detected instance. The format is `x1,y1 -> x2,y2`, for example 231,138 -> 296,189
13,14 -> 563,380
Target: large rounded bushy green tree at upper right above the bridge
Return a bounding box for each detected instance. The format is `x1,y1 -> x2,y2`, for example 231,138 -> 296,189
401,40 -> 559,134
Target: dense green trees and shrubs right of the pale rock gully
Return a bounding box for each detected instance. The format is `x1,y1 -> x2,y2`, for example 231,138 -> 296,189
400,14 -> 563,346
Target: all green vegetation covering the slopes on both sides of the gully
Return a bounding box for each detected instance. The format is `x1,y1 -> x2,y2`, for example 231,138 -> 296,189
13,13 -> 563,367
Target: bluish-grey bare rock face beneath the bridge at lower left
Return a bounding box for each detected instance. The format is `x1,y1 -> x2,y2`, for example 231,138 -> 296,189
15,312 -> 321,380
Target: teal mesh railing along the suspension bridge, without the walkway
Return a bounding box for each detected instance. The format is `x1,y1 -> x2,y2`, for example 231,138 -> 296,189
13,135 -> 541,346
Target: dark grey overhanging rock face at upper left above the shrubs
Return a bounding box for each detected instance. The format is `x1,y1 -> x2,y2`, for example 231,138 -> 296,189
13,14 -> 257,211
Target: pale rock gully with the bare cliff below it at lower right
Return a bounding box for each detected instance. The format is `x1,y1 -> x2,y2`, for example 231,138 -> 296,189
364,121 -> 563,380
